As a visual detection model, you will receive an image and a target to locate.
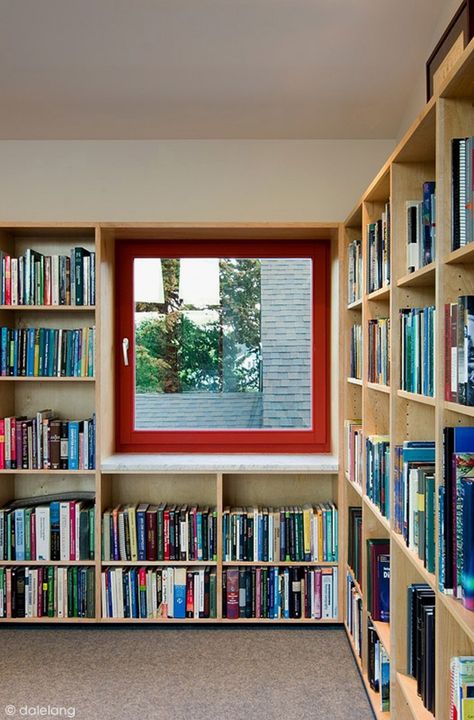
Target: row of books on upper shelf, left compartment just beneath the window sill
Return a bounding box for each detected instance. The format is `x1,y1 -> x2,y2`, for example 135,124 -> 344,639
102,503 -> 217,562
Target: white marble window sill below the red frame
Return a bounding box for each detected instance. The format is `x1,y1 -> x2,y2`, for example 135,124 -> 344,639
101,453 -> 339,475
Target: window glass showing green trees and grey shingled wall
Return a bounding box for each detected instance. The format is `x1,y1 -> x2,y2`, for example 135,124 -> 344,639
134,258 -> 312,430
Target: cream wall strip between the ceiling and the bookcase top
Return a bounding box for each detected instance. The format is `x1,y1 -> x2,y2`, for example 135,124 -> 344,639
0,140 -> 394,222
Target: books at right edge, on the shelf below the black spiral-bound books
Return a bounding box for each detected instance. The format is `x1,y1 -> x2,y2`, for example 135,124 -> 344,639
444,295 -> 474,406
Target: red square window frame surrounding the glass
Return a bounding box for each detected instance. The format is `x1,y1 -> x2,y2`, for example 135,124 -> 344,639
115,240 -> 330,453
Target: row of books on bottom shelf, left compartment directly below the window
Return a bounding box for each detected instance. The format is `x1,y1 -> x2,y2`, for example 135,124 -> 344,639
101,566 -> 217,619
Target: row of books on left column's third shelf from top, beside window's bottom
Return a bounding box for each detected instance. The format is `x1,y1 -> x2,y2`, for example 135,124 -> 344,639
0,409 -> 96,470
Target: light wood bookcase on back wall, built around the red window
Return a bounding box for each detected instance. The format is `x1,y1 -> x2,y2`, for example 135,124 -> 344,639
0,223 -> 344,625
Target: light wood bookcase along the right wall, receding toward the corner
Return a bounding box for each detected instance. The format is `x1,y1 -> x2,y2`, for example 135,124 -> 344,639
339,42 -> 474,720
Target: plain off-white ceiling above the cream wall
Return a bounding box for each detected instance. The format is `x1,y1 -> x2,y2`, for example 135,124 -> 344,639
0,0 -> 446,139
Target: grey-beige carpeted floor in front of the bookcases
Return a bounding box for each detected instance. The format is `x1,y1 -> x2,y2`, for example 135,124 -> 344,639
0,626 -> 373,720
